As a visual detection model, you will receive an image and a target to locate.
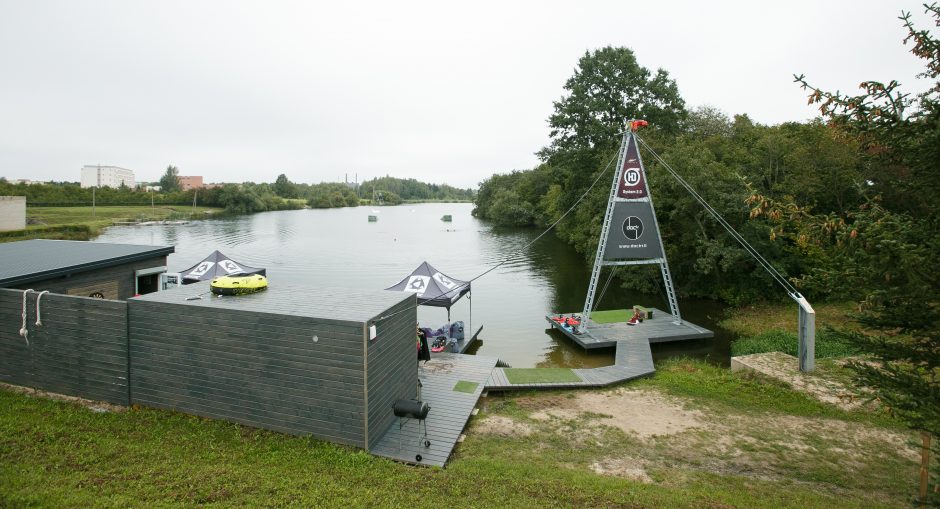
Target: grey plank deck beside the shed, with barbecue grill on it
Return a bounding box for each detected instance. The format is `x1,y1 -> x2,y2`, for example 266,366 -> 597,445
369,352 -> 497,467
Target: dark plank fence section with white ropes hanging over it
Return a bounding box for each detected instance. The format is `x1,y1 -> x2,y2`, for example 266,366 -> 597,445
0,289 -> 130,405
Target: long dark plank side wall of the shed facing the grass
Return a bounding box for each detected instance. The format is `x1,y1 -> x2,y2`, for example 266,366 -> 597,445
129,294 -> 374,447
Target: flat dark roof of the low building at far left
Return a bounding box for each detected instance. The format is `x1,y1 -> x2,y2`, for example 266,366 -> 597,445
0,240 -> 174,287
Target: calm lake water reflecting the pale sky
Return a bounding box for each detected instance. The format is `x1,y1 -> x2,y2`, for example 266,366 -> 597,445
96,203 -> 730,367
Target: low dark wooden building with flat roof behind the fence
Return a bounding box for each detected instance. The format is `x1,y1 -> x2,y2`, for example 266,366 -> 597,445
0,240 -> 174,300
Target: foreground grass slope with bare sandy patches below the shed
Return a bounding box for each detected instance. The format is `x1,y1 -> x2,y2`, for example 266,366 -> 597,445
0,361 -> 917,508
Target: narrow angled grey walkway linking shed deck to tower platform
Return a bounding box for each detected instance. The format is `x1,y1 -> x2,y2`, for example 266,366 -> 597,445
486,339 -> 656,391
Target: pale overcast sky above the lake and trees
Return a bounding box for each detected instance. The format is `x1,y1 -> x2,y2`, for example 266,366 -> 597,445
0,0 -> 931,187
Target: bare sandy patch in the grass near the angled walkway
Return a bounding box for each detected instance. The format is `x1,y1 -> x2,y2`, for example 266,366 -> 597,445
520,389 -> 703,438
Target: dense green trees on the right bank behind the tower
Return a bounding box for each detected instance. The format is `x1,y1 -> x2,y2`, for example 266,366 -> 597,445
474,4 -> 940,502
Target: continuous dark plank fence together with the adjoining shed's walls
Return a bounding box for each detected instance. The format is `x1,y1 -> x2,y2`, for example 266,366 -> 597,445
0,289 -> 418,449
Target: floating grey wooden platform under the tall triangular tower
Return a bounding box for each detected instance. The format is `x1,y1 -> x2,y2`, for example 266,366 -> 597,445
545,308 -> 715,349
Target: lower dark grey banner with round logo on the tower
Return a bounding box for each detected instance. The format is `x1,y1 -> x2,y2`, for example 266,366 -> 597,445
604,201 -> 663,262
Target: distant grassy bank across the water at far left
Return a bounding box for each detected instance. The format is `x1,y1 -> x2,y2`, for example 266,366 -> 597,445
0,205 -> 222,242
